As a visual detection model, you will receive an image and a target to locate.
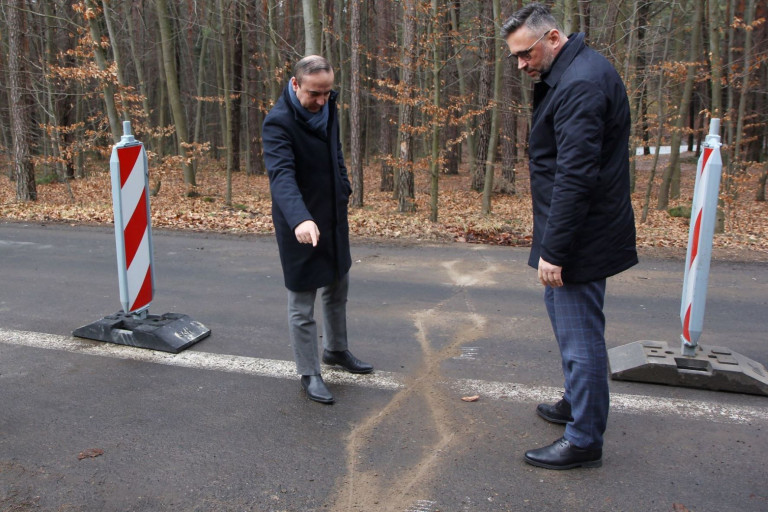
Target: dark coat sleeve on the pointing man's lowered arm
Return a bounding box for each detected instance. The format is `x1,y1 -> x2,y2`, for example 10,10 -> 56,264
262,116 -> 314,229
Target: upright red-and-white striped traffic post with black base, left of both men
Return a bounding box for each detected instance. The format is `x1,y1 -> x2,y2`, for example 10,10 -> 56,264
72,121 -> 211,354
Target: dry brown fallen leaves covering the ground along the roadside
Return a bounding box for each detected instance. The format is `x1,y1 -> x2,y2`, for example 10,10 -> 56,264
0,151 -> 768,254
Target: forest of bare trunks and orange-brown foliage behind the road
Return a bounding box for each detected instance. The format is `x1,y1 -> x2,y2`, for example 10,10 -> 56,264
0,0 -> 768,247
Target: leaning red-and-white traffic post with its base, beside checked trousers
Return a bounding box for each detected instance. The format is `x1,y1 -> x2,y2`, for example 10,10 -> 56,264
608,119 -> 768,395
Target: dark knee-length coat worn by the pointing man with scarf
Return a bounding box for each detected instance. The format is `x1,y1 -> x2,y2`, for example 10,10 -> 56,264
262,83 -> 352,291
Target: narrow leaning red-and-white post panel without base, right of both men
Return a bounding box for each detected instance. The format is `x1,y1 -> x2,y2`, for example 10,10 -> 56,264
680,119 -> 723,356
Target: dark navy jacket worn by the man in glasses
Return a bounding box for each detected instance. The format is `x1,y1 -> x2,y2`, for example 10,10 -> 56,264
528,34 -> 638,283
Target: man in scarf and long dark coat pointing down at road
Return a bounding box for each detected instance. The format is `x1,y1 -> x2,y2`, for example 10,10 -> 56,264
262,55 -> 373,404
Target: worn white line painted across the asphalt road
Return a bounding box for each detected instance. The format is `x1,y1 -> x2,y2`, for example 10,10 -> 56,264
0,328 -> 768,424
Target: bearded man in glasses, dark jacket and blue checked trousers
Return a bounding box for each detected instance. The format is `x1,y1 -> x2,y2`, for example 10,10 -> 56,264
502,3 -> 637,469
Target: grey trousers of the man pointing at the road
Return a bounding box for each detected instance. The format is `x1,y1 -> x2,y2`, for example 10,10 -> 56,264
288,273 -> 349,375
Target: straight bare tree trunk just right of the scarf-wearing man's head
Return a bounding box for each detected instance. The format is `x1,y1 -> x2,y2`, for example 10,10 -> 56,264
348,0 -> 364,207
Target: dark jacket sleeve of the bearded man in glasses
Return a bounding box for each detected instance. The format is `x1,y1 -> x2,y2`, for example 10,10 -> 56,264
541,80 -> 607,266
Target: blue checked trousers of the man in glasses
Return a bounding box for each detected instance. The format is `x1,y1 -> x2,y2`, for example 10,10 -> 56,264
544,279 -> 610,449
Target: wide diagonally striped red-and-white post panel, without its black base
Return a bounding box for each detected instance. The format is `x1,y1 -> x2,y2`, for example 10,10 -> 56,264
110,121 -> 155,315
